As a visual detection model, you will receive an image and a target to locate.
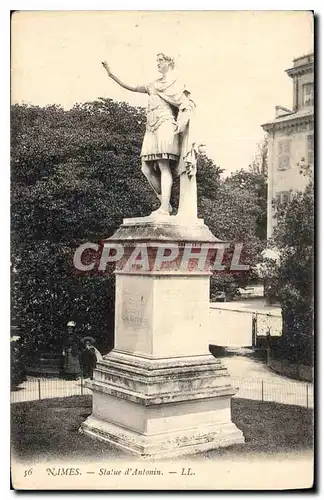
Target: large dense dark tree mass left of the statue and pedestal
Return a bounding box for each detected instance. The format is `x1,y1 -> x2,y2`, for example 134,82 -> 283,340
11,99 -> 151,353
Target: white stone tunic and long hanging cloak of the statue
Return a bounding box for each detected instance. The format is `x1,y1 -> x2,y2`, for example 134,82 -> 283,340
138,74 -> 198,221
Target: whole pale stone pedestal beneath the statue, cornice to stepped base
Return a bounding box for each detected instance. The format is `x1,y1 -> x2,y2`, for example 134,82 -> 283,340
81,217 -> 244,458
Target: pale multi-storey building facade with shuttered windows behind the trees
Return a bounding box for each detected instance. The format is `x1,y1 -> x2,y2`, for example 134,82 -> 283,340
262,54 -> 314,238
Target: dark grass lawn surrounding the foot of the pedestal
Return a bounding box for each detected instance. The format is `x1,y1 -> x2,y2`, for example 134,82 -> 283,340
11,395 -> 313,462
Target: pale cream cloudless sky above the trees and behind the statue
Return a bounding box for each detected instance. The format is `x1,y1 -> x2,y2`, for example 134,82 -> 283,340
11,11 -> 313,174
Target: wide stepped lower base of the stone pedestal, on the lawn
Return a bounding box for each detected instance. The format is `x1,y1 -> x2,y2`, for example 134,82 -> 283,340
80,350 -> 244,458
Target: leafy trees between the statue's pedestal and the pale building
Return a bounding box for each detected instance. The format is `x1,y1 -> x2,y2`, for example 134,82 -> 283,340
202,139 -> 267,295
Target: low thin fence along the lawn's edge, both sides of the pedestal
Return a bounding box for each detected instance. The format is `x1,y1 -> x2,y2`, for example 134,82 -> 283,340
11,377 -> 314,408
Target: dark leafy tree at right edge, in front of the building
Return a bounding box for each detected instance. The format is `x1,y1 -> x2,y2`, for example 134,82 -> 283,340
266,167 -> 314,364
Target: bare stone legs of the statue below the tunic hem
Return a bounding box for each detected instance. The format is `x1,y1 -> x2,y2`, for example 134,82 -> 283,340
142,160 -> 172,214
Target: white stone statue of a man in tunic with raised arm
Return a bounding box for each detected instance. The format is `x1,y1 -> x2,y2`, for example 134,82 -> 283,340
102,53 -> 199,219
